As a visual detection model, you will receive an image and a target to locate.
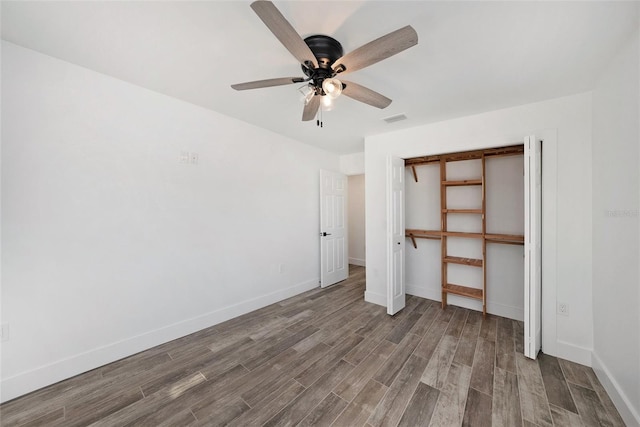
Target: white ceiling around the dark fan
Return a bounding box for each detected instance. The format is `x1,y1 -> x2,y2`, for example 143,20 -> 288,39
1,1 -> 639,154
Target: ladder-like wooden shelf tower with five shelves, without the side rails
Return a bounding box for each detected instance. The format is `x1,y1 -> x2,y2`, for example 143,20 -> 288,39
440,152 -> 487,315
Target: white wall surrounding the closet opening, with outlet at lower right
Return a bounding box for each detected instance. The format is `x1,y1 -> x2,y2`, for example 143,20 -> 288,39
365,93 -> 593,365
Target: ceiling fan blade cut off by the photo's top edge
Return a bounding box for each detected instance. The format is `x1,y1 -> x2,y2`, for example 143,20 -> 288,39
251,0 -> 318,68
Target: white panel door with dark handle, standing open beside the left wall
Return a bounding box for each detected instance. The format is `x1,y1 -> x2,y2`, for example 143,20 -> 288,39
320,170 -> 349,288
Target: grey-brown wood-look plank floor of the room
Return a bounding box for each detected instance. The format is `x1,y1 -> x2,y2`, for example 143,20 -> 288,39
0,266 -> 624,427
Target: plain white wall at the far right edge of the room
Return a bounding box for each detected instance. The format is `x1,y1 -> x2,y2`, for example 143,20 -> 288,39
592,25 -> 640,425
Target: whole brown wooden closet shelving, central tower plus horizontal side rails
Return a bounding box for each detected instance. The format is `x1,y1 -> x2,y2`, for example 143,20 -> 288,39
405,144 -> 524,316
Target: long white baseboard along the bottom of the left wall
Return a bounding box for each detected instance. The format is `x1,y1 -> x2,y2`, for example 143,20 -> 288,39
0,278 -> 318,403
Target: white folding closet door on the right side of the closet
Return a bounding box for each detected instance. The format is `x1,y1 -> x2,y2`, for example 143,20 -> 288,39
524,136 -> 542,359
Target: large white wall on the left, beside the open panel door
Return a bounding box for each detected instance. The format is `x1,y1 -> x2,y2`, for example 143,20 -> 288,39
1,42 -> 339,401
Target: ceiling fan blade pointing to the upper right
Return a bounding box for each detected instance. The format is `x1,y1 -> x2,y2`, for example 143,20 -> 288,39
331,25 -> 418,74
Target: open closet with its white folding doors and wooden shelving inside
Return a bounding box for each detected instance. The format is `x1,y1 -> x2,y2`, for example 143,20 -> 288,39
387,136 -> 553,359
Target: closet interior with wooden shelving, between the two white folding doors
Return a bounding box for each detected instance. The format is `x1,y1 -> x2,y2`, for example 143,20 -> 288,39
405,144 -> 524,317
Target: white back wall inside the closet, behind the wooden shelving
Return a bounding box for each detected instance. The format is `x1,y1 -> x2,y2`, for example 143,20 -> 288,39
405,155 -> 524,320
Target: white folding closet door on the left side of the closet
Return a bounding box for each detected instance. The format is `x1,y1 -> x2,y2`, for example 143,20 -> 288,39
387,157 -> 405,315
